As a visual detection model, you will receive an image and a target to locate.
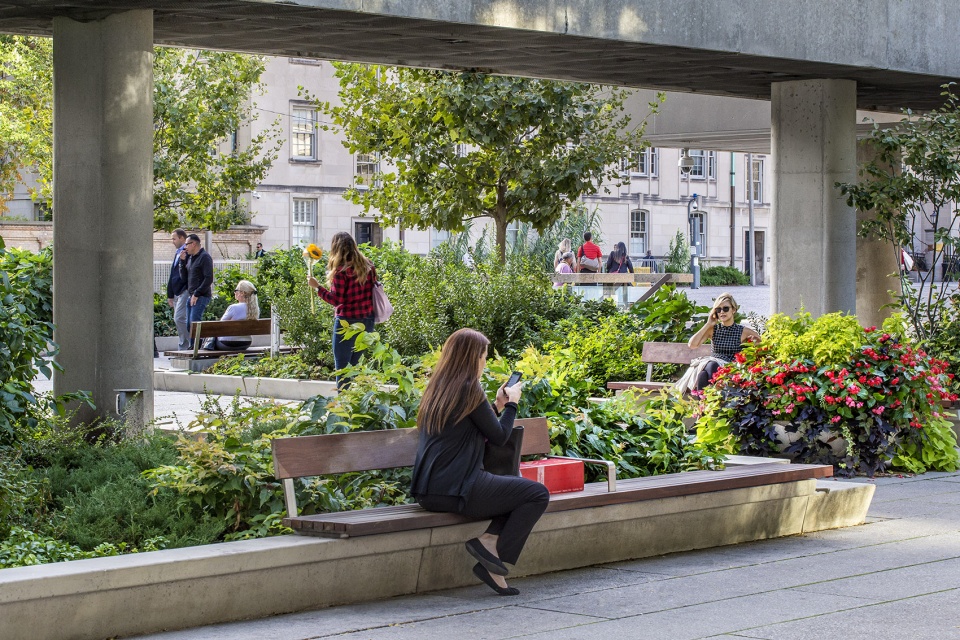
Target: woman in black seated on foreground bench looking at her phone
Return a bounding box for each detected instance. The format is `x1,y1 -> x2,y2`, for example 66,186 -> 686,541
410,329 -> 550,596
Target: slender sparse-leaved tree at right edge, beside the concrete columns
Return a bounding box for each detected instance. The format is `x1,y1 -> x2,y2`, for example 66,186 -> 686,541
837,85 -> 960,341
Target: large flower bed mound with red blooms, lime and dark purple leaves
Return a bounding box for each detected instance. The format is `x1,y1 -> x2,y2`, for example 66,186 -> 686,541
697,313 -> 960,476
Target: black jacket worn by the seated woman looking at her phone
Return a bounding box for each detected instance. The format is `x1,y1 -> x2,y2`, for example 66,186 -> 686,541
410,401 -> 517,505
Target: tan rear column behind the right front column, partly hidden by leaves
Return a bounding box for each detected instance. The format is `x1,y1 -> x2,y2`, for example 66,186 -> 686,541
857,140 -> 900,327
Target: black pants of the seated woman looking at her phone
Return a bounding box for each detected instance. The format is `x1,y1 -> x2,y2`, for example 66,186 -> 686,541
417,471 -> 550,564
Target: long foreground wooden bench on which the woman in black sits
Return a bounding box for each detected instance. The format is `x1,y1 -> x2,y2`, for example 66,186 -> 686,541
272,418 -> 833,538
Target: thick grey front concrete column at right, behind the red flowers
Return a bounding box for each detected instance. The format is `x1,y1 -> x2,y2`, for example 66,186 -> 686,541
770,80 -> 857,316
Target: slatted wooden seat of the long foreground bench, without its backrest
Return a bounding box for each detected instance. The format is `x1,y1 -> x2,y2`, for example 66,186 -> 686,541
283,463 -> 833,537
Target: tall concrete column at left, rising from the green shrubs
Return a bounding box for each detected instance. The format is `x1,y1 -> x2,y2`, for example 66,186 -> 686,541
53,10 -> 153,424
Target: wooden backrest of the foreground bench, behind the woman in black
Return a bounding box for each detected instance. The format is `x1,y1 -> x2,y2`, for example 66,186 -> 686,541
272,418 -> 550,480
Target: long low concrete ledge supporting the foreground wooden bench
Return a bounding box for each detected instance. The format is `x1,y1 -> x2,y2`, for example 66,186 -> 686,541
0,479 -> 874,640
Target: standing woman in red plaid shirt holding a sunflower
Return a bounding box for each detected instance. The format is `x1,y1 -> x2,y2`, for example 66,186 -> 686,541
307,231 -> 377,389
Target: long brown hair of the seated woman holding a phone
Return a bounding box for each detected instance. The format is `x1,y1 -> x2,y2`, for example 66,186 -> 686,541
417,329 -> 490,433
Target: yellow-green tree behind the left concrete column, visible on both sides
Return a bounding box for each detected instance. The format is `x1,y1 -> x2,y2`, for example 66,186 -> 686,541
0,36 -> 281,231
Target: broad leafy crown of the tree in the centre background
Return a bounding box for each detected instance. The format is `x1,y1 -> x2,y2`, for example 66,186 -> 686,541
316,64 -> 663,260
